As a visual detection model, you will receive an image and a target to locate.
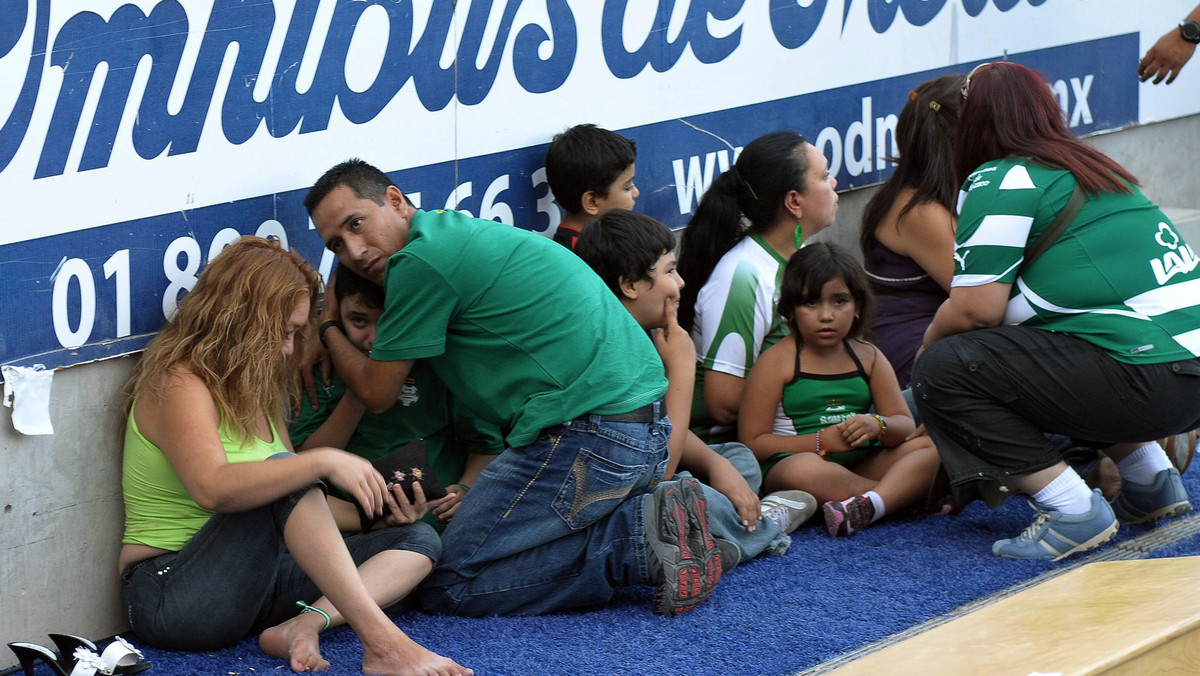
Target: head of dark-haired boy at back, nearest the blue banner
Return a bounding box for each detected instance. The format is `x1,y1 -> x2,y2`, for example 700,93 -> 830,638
546,124 -> 637,220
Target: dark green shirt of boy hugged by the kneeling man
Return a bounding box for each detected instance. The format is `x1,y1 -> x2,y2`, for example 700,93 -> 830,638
290,361 -> 504,486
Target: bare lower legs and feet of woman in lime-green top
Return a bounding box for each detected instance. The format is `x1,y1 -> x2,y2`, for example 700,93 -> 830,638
259,490 -> 473,676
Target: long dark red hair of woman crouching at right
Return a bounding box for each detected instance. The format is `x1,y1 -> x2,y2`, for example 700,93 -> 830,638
954,61 -> 1138,195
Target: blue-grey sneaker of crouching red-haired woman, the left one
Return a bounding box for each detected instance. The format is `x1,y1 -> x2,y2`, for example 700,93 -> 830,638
991,489 -> 1117,561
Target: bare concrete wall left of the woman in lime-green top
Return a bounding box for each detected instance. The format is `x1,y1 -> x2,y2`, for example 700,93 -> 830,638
0,357 -> 133,653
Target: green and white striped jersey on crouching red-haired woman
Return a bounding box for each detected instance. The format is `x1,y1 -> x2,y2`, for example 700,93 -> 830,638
950,157 -> 1200,364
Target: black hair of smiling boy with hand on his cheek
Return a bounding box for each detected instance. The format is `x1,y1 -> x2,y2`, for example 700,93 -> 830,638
575,209 -> 686,298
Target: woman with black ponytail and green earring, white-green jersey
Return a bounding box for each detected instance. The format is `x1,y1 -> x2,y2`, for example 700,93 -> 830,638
679,131 -> 838,441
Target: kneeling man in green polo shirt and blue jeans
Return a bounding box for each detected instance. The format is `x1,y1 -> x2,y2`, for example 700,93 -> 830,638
305,160 -> 727,615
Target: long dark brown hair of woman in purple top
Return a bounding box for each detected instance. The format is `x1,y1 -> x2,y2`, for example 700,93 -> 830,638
858,73 -> 965,258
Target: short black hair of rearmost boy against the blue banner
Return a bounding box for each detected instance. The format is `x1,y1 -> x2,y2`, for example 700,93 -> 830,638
546,125 -> 637,214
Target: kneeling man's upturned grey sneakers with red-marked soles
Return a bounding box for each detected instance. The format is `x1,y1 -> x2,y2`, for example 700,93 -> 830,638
644,478 -> 720,616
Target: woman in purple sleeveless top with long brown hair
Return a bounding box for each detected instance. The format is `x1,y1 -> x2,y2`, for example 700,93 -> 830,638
859,73 -> 964,388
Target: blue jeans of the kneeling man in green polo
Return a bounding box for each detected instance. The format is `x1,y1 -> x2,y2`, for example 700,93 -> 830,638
420,402 -> 671,616
